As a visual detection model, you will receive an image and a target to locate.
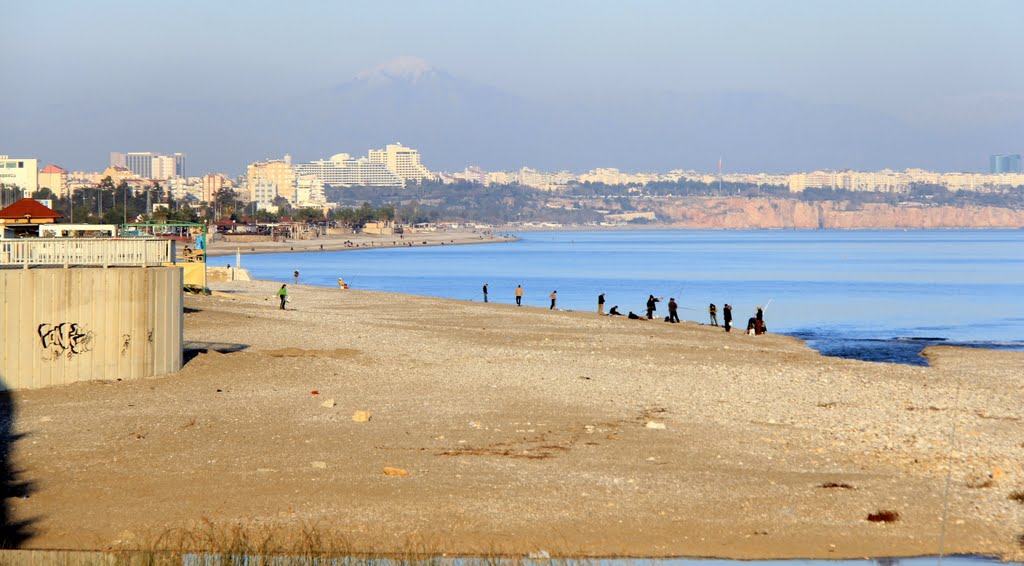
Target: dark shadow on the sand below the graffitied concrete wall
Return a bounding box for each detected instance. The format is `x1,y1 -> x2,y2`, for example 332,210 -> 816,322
0,376 -> 35,549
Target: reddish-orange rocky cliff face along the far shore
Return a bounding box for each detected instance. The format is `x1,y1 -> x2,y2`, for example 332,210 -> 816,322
636,198 -> 1024,229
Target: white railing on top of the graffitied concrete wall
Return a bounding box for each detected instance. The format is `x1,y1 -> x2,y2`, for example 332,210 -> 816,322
0,237 -> 174,268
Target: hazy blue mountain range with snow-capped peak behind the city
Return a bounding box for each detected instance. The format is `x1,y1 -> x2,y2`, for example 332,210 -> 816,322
6,57 -> 1024,173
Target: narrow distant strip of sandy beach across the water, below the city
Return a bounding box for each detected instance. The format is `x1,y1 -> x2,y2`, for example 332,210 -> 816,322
207,230 -> 516,257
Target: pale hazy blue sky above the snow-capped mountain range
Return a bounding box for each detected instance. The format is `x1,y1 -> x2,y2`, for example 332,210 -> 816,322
0,0 -> 1024,170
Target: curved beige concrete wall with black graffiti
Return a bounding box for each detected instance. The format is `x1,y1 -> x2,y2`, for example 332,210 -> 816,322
0,267 -> 183,389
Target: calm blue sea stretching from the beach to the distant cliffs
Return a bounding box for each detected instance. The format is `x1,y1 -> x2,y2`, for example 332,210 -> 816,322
210,230 -> 1024,363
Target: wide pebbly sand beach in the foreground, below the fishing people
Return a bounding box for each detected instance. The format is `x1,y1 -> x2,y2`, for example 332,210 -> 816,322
7,281 -> 1024,560
